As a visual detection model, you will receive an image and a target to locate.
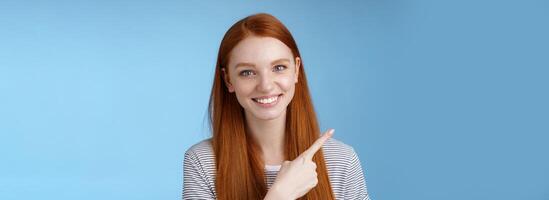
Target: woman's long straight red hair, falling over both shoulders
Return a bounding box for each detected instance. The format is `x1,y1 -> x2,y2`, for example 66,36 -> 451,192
208,13 -> 334,200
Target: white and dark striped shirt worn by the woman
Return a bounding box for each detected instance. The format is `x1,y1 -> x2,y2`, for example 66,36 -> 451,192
183,138 -> 370,200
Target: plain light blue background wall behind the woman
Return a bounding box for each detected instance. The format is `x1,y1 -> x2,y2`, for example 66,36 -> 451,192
0,0 -> 549,200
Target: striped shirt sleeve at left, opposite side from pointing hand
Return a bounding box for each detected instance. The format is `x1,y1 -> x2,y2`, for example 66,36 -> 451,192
183,150 -> 215,200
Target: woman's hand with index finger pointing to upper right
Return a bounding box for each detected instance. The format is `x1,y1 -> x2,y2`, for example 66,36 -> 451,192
265,129 -> 334,200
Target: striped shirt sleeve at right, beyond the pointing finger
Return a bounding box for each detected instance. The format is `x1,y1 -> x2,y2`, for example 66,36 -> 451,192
344,149 -> 370,200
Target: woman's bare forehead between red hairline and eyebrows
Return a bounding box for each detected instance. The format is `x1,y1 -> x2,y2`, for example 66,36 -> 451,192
229,36 -> 293,66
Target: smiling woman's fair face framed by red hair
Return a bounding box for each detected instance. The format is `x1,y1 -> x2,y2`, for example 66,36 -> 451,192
224,36 -> 301,120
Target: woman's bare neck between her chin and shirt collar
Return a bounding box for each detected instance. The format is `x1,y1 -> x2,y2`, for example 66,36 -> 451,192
246,111 -> 286,165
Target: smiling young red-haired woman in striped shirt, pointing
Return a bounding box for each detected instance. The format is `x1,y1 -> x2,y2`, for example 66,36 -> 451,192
183,14 -> 369,200
